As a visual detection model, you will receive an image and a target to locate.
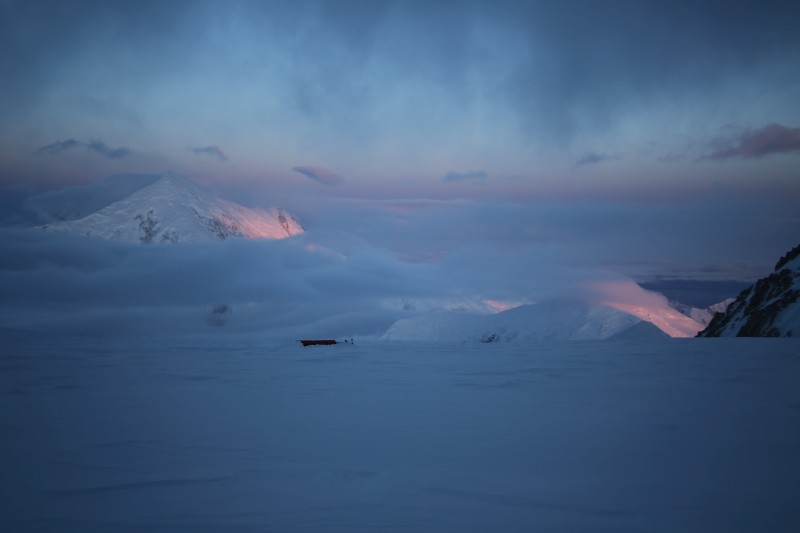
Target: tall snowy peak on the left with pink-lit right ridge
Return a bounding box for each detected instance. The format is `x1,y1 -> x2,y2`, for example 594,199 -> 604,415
42,173 -> 303,244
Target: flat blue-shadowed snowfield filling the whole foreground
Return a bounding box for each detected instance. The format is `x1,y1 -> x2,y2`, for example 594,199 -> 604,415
0,330 -> 800,532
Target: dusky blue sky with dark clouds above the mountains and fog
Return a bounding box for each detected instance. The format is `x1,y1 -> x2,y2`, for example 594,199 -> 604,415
0,1 -> 800,282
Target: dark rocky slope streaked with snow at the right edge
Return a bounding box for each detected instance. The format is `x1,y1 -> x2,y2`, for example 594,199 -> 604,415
698,245 -> 800,337
